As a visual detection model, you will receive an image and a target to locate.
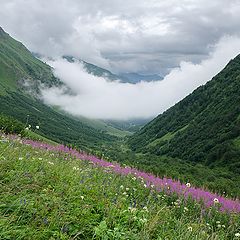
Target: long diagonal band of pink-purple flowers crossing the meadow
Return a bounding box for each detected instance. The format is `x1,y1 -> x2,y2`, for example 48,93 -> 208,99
18,137 -> 240,213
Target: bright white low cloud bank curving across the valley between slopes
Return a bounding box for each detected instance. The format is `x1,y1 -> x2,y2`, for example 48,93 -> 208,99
42,36 -> 240,119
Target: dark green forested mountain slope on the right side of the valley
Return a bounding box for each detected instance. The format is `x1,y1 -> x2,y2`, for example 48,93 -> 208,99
128,55 -> 240,173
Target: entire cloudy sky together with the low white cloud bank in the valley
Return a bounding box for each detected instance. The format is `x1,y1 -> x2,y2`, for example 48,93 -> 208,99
0,0 -> 240,119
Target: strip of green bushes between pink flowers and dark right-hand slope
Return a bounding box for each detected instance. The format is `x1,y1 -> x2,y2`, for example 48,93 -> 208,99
104,144 -> 240,197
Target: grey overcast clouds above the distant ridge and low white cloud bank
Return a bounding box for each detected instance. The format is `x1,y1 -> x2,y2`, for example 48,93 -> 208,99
0,0 -> 240,75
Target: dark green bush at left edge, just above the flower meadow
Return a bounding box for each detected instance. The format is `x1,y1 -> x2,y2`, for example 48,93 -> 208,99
0,114 -> 24,134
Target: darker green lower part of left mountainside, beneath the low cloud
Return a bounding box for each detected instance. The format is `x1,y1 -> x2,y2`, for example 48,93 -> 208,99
0,93 -> 117,150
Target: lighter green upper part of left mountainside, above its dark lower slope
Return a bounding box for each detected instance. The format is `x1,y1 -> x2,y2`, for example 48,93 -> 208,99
0,28 -> 61,94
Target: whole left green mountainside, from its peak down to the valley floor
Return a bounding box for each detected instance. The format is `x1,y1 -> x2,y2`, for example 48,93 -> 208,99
0,28 -> 127,149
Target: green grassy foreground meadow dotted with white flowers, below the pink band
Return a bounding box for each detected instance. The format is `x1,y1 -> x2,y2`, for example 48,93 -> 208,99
0,139 -> 240,240
